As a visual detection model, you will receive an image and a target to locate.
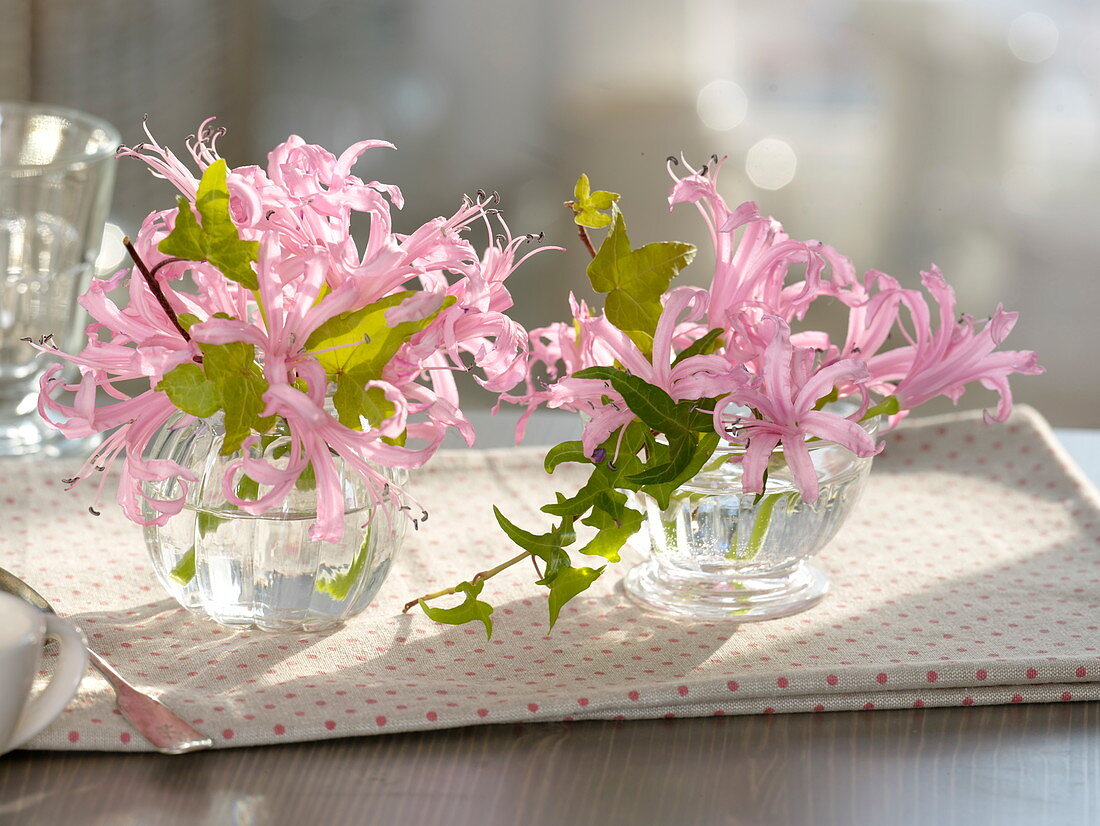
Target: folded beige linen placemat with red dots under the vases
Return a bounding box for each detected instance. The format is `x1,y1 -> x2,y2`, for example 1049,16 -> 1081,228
8,408 -> 1100,751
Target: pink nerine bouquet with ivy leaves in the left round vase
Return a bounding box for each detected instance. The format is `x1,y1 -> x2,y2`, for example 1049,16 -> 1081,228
39,121 -> 545,542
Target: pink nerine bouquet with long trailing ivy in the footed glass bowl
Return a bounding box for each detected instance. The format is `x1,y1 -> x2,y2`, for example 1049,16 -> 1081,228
409,157 -> 1042,629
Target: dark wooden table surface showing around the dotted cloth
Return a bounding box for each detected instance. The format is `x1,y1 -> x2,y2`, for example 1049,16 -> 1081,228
0,417 -> 1100,826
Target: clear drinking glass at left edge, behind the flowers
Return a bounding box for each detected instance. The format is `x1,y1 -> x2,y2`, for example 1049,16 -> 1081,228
0,102 -> 120,455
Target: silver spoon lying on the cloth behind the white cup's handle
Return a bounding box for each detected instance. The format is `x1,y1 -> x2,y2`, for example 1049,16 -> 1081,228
0,568 -> 213,755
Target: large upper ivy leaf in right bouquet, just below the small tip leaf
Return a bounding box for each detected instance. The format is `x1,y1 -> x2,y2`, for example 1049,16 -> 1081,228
587,213 -> 695,346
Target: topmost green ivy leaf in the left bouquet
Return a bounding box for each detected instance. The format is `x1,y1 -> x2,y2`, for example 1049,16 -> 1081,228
156,158 -> 260,289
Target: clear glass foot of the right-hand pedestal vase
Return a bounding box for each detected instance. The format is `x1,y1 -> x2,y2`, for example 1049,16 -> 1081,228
623,560 -> 828,623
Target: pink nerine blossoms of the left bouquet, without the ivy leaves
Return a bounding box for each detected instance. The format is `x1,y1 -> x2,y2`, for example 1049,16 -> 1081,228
39,121 -> 550,541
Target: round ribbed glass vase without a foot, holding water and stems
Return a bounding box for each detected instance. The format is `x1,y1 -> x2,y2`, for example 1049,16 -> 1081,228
144,416 -> 408,631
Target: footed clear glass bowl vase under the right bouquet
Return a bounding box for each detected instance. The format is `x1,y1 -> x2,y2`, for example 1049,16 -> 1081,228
624,421 -> 878,623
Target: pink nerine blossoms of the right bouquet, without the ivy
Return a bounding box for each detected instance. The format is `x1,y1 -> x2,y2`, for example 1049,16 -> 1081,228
502,158 -> 1043,503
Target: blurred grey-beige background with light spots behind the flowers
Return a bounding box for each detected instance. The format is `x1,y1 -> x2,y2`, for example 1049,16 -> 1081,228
0,0 -> 1100,427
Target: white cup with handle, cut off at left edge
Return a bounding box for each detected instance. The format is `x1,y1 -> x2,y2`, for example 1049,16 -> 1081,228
0,594 -> 88,755
